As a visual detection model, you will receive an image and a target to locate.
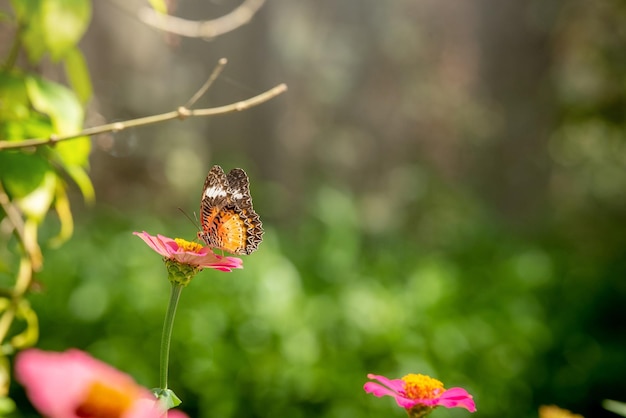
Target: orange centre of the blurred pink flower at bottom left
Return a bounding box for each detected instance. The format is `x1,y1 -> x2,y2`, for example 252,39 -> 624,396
76,382 -> 136,418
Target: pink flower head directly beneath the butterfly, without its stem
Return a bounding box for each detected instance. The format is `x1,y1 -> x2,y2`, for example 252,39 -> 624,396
133,231 -> 243,271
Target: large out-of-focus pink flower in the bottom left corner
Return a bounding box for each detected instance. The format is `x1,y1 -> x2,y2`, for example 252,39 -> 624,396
15,349 -> 186,418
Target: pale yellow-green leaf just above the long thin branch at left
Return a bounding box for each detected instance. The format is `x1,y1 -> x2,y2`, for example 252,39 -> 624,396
26,77 -> 84,135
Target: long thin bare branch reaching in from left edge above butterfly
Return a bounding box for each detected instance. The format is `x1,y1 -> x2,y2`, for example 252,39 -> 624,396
0,84 -> 287,151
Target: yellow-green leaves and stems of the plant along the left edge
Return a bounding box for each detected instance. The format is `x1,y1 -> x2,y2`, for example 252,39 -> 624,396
0,0 -> 94,404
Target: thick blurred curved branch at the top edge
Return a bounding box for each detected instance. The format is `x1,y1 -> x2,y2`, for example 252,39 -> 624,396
139,0 -> 265,39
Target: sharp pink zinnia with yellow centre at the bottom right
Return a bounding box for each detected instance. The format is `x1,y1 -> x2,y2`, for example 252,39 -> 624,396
363,374 -> 476,417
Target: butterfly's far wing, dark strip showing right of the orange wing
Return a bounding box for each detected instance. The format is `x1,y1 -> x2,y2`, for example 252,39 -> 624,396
226,168 -> 263,254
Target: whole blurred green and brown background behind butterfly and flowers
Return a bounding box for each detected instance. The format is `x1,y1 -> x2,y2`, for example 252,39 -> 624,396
1,0 -> 626,418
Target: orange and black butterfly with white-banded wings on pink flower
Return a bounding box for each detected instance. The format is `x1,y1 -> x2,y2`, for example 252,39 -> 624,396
198,165 -> 263,255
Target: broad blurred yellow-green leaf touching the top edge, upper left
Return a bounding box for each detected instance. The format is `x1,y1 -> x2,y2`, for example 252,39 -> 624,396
41,0 -> 91,61
